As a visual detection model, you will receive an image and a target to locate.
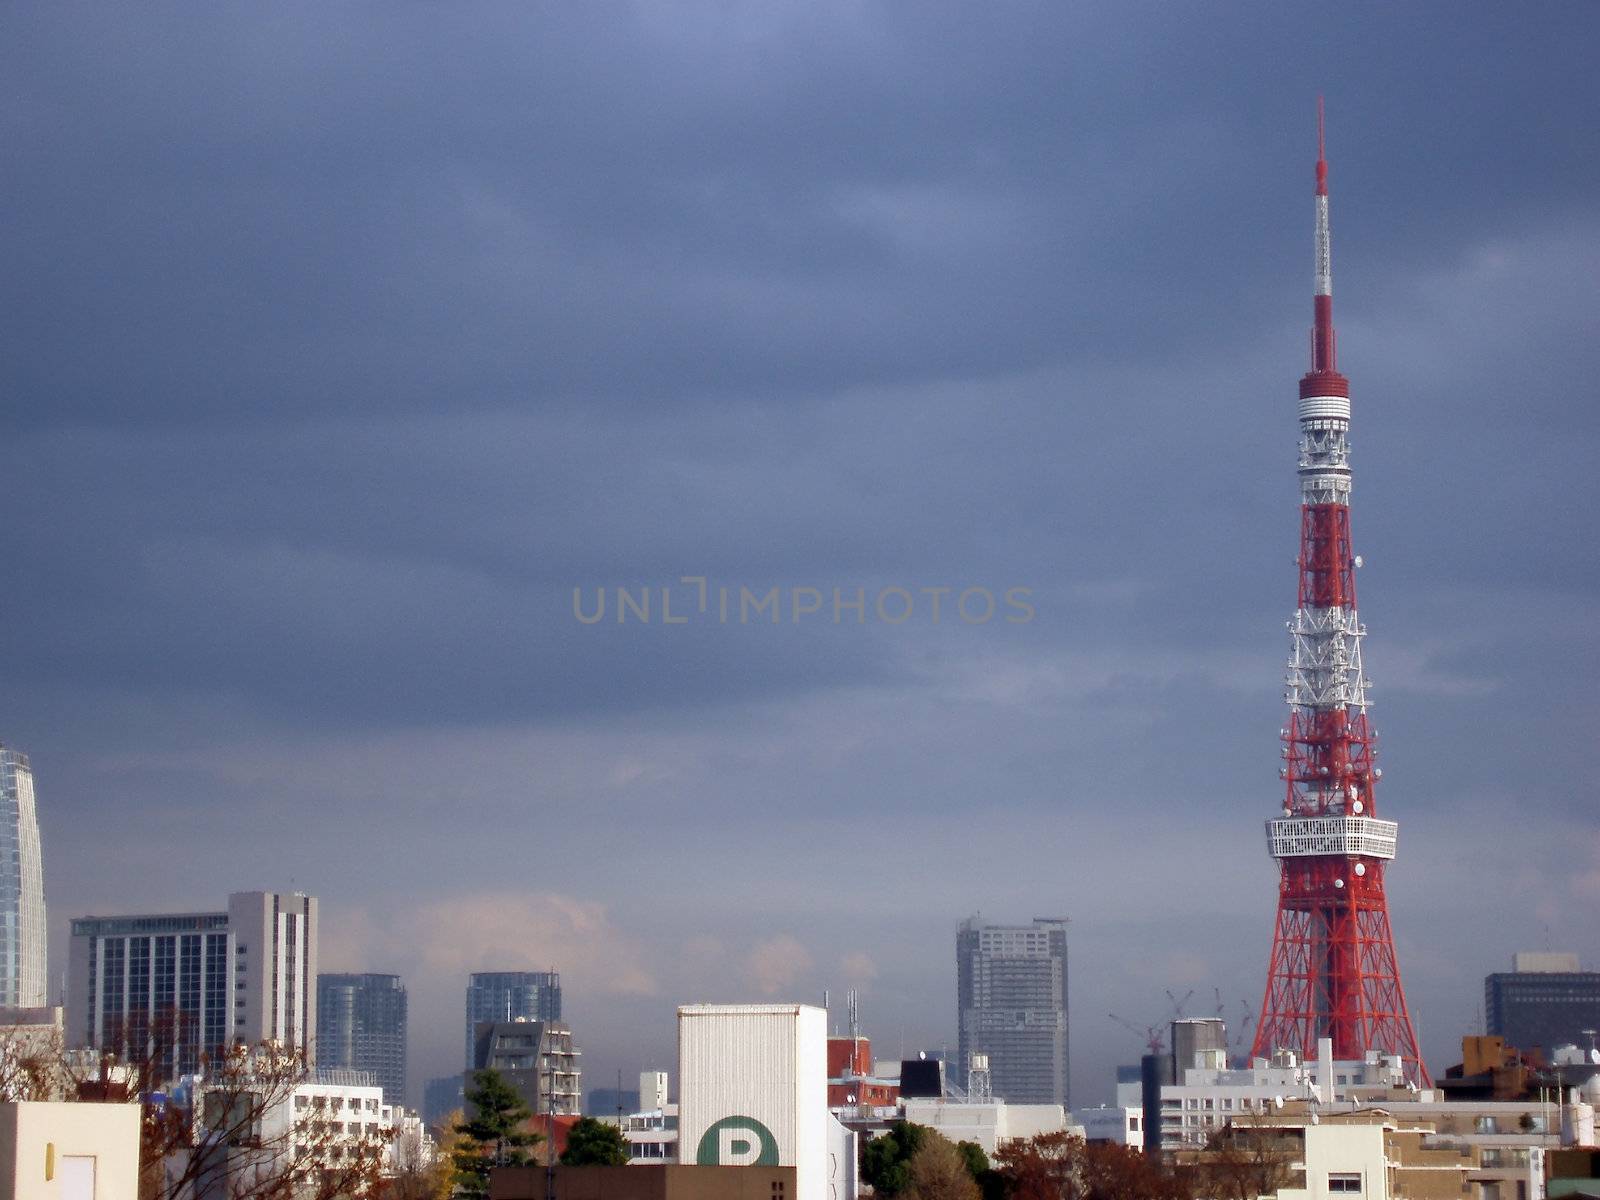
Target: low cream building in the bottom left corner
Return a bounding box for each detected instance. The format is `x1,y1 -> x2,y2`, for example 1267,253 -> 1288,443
0,1102 -> 139,1200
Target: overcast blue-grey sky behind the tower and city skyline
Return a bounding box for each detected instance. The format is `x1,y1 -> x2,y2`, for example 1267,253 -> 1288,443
0,0 -> 1600,1102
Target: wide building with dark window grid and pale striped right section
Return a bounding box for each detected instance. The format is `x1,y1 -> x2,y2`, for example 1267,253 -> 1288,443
67,891 -> 317,1078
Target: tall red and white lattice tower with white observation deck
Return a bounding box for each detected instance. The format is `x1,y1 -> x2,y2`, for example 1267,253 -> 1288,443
1250,102 -> 1427,1085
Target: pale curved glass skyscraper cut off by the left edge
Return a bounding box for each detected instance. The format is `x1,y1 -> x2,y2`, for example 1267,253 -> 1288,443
0,744 -> 48,1008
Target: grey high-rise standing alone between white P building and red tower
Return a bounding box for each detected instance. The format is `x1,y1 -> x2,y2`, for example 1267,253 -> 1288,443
955,917 -> 1072,1107
